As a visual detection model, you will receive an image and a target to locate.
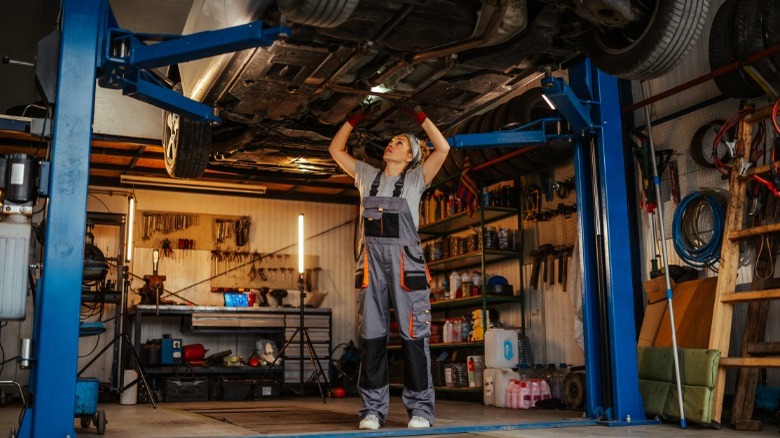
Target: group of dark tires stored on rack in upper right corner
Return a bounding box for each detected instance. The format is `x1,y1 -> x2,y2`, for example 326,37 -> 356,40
709,0 -> 780,99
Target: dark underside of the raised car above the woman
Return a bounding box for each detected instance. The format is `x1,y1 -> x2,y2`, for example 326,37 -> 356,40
163,0 -> 708,186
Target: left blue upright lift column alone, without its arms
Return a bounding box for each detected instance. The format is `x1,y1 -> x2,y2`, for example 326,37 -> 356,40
20,0 -> 103,437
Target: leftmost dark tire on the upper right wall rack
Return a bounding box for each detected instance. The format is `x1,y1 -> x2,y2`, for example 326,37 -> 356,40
709,0 -> 764,99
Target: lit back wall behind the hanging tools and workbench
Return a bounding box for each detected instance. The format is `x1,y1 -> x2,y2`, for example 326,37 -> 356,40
70,186 -> 357,379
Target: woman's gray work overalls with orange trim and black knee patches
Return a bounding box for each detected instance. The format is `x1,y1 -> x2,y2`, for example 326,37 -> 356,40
355,171 -> 435,424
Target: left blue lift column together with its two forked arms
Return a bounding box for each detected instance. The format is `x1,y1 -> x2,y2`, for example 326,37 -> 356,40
19,0 -> 290,437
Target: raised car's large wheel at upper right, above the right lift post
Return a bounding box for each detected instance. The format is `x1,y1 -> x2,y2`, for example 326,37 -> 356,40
584,0 -> 709,80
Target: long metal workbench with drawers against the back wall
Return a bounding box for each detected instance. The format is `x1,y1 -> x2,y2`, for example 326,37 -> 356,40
128,304 -> 332,384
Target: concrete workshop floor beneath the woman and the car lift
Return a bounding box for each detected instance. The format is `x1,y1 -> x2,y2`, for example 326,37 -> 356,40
0,397 -> 778,438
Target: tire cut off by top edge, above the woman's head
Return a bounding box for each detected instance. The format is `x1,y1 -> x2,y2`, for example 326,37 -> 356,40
277,0 -> 360,28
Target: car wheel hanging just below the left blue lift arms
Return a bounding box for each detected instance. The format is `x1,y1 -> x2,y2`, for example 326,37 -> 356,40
163,84 -> 211,178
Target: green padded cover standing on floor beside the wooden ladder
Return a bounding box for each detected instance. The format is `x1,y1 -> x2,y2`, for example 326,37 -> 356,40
637,347 -> 720,423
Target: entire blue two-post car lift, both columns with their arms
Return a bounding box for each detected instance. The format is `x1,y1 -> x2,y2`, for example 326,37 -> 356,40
19,0 -> 655,437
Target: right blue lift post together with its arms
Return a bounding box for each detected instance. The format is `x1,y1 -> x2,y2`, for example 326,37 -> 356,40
450,59 -> 658,426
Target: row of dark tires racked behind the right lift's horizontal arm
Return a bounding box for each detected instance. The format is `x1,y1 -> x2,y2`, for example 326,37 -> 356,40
434,87 -> 572,191
